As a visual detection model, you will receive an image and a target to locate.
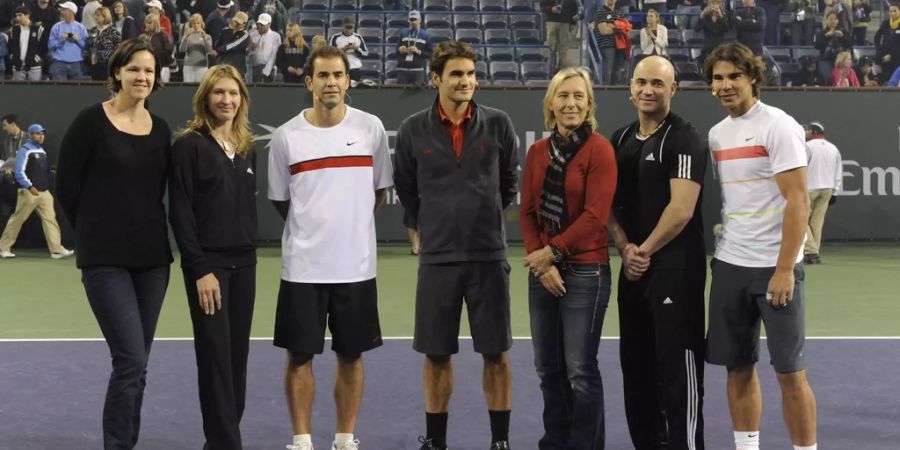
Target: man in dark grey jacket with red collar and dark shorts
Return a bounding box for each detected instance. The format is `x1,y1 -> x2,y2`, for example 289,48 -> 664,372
394,42 -> 518,450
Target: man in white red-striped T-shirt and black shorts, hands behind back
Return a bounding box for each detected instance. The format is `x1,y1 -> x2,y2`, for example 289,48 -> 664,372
269,47 -> 393,450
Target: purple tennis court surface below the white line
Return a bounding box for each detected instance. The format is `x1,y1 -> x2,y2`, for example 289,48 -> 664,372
0,338 -> 900,450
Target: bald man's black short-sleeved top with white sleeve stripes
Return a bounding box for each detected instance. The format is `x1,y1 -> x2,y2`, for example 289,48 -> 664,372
611,112 -> 709,269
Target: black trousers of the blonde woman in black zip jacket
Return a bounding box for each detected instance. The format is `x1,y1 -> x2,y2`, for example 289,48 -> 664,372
184,265 -> 256,450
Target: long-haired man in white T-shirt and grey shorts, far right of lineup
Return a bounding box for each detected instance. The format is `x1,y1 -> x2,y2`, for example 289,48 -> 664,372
704,43 -> 816,450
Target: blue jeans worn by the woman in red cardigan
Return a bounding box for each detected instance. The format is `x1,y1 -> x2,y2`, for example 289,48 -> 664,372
528,264 -> 610,450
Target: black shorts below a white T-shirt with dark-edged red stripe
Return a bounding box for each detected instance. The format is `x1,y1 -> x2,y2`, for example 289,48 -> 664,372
274,278 -> 382,355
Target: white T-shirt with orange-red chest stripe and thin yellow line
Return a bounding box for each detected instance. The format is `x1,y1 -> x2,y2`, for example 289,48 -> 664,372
709,101 -> 806,267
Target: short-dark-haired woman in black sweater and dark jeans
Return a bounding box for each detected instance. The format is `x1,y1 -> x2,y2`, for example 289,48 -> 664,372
57,40 -> 172,449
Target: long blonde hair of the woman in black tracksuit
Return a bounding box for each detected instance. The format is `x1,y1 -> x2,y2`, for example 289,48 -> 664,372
178,64 -> 255,156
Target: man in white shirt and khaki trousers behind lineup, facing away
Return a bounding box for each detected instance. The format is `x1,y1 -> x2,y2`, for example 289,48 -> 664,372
803,122 -> 844,264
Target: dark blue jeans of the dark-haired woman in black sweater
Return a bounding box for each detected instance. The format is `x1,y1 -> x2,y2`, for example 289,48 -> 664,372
81,266 -> 169,450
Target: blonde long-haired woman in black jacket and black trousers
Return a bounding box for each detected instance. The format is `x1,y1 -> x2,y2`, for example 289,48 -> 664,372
169,64 -> 256,449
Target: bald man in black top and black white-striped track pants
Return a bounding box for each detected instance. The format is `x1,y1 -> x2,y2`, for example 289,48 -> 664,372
609,56 -> 707,450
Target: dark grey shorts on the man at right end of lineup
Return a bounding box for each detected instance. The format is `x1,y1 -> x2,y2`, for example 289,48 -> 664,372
706,259 -> 806,373
